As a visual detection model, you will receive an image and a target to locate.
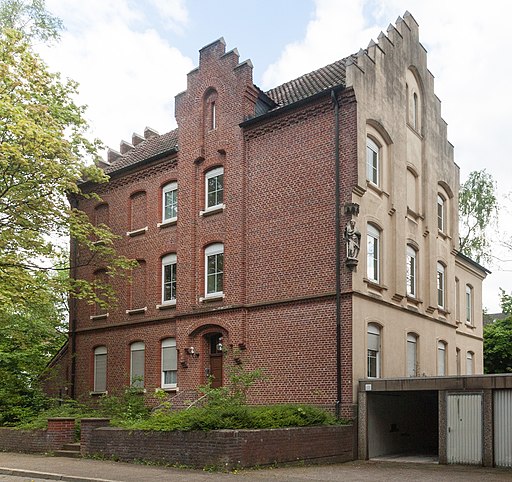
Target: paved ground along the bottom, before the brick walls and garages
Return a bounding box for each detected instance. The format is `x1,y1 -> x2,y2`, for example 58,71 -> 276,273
0,452 -> 512,482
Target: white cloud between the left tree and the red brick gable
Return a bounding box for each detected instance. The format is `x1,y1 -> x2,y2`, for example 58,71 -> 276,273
42,0 -> 194,149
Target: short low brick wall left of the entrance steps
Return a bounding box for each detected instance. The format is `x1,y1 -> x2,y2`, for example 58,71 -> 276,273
0,418 -> 75,452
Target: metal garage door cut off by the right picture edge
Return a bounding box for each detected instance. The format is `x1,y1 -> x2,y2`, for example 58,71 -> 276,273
494,390 -> 512,467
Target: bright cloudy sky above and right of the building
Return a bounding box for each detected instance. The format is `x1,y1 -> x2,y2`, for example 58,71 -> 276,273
39,0 -> 512,313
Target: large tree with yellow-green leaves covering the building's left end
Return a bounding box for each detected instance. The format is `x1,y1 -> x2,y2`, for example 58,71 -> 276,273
0,29 -> 135,309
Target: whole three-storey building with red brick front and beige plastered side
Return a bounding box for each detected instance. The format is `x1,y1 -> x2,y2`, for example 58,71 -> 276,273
48,12 -> 486,416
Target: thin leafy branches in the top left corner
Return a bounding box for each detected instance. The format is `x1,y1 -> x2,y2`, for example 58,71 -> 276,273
0,0 -> 63,42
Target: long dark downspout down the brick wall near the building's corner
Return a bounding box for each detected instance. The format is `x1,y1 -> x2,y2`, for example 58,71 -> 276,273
331,89 -> 341,418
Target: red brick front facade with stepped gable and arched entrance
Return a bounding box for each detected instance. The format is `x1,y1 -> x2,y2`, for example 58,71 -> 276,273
48,36 -> 357,415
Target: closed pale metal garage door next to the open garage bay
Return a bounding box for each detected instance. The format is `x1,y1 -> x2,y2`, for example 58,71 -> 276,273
446,393 -> 482,464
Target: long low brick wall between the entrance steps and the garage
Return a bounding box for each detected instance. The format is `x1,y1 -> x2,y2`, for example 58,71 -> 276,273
82,425 -> 354,469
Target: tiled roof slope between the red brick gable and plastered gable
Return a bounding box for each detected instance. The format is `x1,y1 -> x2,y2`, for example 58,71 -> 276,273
266,55 -> 354,108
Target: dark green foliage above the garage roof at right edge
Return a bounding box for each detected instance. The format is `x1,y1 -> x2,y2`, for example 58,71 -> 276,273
484,315 -> 512,373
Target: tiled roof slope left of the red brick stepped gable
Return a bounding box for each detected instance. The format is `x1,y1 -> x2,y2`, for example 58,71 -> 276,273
105,129 -> 178,174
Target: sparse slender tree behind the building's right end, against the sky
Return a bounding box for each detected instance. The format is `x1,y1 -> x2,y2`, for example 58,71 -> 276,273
459,169 -> 498,262
